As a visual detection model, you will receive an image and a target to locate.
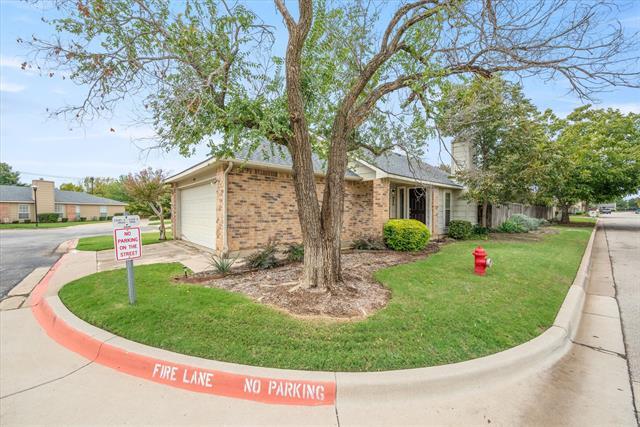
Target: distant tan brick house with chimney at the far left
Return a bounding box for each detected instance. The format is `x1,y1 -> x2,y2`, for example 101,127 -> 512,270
0,179 -> 127,223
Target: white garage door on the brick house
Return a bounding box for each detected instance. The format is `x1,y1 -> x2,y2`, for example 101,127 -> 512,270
180,183 -> 216,249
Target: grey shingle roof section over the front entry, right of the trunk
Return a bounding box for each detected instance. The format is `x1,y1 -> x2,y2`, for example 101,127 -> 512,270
371,152 -> 462,187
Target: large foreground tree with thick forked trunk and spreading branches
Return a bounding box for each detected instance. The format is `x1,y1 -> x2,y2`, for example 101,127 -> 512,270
26,0 -> 638,290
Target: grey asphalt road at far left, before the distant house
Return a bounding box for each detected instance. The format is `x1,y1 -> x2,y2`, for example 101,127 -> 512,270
0,222 -> 157,298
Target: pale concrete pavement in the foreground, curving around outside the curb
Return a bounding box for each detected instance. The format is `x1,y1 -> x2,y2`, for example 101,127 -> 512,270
0,227 -> 636,426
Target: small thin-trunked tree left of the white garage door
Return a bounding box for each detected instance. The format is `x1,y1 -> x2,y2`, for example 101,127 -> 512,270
124,168 -> 171,240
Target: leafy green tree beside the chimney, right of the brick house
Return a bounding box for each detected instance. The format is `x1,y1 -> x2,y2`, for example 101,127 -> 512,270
437,76 -> 545,227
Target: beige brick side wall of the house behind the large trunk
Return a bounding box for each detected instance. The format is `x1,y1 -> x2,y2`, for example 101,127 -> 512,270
225,169 -> 376,251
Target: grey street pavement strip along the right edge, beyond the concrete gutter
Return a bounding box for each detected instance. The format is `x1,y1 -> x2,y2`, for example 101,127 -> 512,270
602,213 -> 640,420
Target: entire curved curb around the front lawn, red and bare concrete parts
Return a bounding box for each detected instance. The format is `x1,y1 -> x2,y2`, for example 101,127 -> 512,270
31,227 -> 597,406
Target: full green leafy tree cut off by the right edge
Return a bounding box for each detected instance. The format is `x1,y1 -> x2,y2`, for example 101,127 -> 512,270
537,105 -> 640,223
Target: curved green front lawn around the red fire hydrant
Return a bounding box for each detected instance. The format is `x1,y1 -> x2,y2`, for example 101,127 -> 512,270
60,228 -> 591,371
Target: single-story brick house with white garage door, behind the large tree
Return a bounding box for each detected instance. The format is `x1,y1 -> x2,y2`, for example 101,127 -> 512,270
166,145 -> 476,253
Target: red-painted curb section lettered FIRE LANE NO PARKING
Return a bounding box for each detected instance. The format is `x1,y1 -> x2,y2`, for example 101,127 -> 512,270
31,255 -> 336,406
